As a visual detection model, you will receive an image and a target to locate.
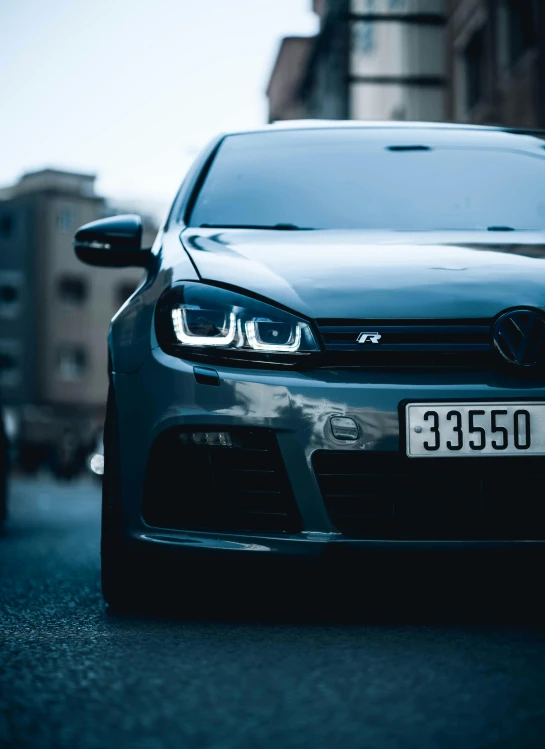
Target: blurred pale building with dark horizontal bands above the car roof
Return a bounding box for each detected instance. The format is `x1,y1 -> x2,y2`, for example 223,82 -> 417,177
267,0 -> 447,121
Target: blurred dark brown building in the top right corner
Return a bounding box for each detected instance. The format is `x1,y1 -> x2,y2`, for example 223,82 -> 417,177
446,0 -> 545,128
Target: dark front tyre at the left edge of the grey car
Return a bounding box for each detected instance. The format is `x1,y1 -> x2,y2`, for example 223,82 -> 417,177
100,384 -> 148,609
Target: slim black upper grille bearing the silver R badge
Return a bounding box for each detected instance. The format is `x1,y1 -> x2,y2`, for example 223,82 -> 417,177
317,319 -> 496,369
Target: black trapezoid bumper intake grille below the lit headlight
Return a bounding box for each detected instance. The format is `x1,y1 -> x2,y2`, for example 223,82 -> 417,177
142,427 -> 301,533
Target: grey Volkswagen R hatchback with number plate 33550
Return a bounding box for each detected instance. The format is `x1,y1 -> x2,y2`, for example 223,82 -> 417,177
74,121 -> 545,606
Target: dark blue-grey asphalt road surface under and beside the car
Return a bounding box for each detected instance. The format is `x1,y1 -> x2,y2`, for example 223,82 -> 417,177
0,480 -> 545,749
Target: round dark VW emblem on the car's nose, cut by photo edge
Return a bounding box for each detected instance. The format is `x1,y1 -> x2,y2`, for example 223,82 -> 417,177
492,309 -> 545,367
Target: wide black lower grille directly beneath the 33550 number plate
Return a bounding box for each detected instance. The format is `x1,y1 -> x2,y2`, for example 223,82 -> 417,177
313,450 -> 545,541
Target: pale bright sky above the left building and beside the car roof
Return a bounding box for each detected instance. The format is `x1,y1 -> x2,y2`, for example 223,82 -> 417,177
0,0 -> 317,219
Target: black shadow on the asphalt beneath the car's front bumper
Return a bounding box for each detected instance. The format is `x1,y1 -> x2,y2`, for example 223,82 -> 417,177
107,552 -> 545,628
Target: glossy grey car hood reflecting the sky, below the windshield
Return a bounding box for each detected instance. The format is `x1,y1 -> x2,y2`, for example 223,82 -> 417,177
181,229 -> 545,319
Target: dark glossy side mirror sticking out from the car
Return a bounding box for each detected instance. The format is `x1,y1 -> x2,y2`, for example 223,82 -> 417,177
74,214 -> 151,268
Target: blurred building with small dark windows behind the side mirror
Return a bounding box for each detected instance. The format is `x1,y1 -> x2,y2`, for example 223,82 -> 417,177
0,169 -> 153,462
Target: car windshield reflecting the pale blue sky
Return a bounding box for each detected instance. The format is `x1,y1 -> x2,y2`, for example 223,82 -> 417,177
188,128 -> 545,231
